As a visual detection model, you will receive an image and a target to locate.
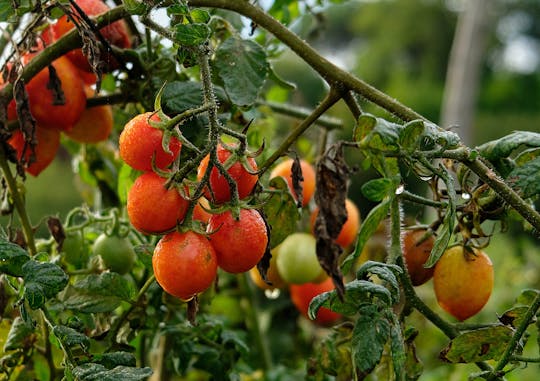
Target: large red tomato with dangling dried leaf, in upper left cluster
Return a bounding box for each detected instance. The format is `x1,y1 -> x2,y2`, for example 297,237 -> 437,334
8,55 -> 86,131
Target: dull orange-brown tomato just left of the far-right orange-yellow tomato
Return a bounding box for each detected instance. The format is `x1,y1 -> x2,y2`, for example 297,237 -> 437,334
402,229 -> 435,286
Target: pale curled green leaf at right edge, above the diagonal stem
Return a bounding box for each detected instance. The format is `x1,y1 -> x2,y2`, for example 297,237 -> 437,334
476,131 -> 540,162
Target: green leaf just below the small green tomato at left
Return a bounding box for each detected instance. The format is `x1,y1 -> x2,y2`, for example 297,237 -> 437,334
63,272 -> 134,313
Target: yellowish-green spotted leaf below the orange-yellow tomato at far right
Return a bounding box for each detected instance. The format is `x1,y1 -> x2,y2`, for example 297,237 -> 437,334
440,326 -> 514,363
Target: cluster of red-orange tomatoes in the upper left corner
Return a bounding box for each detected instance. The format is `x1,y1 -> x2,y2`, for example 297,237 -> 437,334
0,0 -> 131,176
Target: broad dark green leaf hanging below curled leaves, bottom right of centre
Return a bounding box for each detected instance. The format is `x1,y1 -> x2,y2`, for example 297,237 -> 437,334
351,304 -> 391,374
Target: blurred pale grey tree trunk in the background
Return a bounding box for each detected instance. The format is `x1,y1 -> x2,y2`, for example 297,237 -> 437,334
440,0 -> 491,145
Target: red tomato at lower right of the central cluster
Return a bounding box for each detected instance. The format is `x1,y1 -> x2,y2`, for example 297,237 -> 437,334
207,209 -> 268,274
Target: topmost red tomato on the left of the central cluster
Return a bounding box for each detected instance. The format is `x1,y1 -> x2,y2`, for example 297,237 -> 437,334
118,112 -> 182,171
